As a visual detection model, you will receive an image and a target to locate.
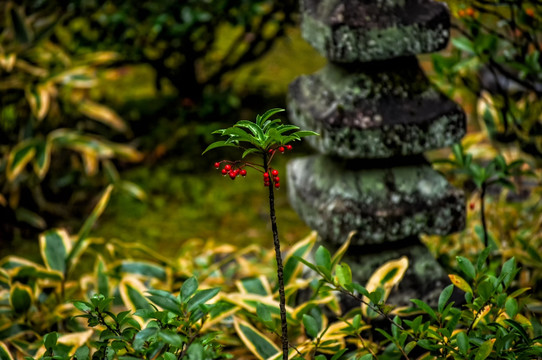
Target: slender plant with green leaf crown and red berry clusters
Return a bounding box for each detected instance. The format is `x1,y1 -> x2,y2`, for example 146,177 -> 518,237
203,108 -> 318,360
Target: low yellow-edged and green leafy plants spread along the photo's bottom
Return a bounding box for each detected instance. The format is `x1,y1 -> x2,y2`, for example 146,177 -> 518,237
0,189 -> 542,360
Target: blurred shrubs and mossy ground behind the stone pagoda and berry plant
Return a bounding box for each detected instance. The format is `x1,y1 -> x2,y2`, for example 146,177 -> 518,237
0,0 -> 542,278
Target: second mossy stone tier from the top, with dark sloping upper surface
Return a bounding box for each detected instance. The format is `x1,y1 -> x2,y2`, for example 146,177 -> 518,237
288,57 -> 466,158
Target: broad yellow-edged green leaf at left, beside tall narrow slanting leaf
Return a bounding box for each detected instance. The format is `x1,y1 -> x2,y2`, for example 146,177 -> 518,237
39,229 -> 72,274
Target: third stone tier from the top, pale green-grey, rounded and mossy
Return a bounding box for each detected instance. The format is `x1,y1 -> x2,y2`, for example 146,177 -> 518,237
288,155 -> 465,246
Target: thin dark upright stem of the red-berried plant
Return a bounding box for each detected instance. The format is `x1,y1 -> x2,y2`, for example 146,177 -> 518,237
263,154 -> 288,360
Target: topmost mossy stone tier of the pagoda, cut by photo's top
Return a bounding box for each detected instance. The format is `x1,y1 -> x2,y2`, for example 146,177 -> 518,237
301,0 -> 450,62
